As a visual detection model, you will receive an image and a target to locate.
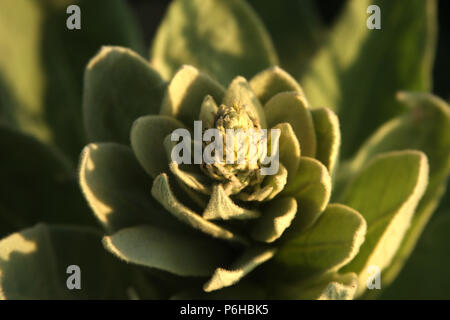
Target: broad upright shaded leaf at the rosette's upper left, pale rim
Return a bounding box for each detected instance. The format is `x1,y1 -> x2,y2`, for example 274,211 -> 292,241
83,47 -> 165,144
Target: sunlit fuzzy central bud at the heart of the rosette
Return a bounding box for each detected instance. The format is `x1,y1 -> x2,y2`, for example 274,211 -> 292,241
202,103 -> 263,194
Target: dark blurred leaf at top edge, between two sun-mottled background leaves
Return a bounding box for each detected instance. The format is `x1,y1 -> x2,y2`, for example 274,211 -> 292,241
248,0 -> 325,78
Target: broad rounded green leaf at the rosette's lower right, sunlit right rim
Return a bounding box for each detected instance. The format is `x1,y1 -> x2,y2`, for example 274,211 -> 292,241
274,202 -> 366,272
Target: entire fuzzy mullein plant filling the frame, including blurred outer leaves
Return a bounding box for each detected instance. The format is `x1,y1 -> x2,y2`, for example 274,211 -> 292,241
0,0 -> 450,299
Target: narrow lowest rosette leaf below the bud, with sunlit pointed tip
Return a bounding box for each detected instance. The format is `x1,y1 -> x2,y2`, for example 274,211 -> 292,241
203,247 -> 275,292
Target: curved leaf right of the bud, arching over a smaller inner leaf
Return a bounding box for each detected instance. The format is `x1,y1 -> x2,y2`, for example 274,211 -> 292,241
264,92 -> 316,157
